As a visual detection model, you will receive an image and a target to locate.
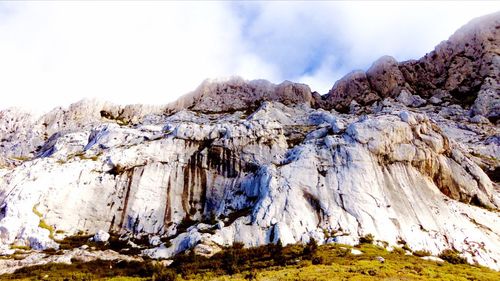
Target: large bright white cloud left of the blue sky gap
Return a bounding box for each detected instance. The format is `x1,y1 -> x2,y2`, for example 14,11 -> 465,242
0,2 -> 282,110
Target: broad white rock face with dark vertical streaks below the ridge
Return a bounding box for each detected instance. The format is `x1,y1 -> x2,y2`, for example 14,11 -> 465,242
0,99 -> 500,269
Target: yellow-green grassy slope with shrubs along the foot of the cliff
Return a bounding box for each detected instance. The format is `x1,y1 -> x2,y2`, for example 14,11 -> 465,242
0,238 -> 500,281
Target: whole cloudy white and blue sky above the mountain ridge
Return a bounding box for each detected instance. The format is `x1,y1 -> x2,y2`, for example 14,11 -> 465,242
0,1 -> 500,111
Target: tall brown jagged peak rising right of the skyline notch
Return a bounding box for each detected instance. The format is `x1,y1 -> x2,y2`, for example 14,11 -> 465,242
318,12 -> 500,118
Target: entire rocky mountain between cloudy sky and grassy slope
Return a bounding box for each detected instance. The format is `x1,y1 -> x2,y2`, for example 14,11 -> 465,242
0,13 -> 500,271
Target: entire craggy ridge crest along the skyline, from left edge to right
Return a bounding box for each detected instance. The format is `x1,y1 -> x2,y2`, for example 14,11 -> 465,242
0,10 -> 500,166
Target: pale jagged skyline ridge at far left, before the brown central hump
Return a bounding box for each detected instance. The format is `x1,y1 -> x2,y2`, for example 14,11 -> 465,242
0,99 -> 164,166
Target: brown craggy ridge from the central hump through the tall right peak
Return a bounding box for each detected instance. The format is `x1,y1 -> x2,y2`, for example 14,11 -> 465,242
167,8 -> 500,117
